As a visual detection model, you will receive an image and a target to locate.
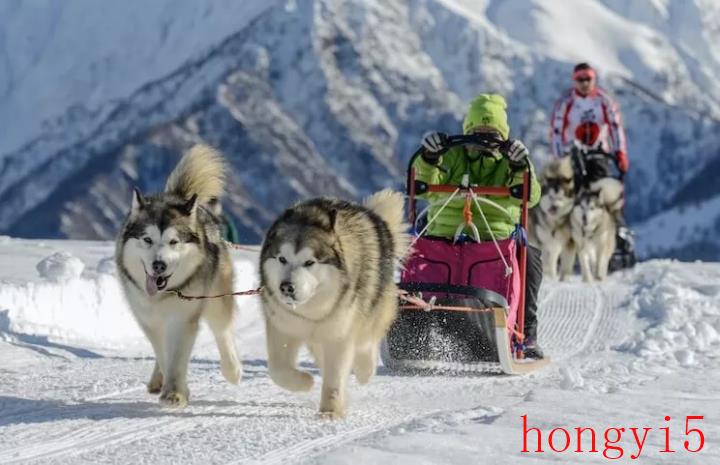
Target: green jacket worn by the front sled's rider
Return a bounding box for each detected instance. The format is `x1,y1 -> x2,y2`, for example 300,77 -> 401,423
413,147 -> 540,241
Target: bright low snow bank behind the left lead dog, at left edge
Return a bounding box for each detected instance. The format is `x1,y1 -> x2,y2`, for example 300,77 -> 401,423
0,239 -> 256,349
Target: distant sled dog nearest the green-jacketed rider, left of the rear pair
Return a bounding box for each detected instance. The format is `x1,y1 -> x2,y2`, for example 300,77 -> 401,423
529,157 -> 575,279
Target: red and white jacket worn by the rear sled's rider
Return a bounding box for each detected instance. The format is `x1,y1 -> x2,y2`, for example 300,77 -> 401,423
550,87 -> 627,157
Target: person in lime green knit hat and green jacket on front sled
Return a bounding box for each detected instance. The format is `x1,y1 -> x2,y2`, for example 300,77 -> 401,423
413,94 -> 543,358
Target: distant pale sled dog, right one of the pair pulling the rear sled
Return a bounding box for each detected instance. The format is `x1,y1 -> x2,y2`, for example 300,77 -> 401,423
570,178 -> 624,282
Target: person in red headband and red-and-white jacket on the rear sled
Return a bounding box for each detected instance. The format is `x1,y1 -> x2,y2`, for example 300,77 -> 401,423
550,63 -> 629,175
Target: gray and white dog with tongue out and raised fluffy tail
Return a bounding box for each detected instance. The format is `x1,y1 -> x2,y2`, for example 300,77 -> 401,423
115,145 -> 242,406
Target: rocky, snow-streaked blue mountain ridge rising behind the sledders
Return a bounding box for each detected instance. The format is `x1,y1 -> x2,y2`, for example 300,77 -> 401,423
0,0 -> 720,256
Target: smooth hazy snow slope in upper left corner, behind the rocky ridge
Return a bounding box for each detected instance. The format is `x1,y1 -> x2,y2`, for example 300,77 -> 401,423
0,0 -> 278,156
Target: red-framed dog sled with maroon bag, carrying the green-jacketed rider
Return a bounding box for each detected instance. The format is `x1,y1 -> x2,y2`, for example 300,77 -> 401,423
381,135 -> 550,374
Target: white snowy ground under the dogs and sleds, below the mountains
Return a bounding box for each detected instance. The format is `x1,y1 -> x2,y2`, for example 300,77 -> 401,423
0,237 -> 720,465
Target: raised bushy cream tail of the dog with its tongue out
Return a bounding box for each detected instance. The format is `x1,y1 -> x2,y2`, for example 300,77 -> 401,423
165,144 -> 225,204
